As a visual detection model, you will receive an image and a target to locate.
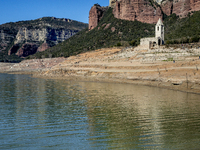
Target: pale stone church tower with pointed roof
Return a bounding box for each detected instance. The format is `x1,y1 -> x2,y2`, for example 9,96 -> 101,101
155,18 -> 165,45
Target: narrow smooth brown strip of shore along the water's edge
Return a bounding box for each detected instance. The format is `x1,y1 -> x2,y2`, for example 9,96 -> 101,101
32,70 -> 200,94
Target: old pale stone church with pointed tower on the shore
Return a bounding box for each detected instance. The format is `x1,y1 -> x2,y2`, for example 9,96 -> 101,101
140,18 -> 164,49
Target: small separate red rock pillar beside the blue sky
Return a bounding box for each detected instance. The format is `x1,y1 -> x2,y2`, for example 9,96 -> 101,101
89,5 -> 107,30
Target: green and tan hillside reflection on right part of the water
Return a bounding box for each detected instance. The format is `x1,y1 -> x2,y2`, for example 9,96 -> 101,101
77,82 -> 200,148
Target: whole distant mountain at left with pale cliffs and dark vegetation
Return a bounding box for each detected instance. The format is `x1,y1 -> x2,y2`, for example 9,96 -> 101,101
0,17 -> 88,62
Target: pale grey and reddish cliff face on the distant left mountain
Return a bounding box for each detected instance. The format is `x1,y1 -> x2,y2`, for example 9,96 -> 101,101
8,27 -> 78,57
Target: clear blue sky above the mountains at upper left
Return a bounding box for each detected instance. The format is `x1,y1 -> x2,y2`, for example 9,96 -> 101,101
0,0 -> 109,24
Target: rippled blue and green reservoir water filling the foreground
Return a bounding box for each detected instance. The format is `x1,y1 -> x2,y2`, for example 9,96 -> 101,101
0,74 -> 200,150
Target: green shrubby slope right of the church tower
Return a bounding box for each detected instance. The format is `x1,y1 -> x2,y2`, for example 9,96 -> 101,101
164,11 -> 200,44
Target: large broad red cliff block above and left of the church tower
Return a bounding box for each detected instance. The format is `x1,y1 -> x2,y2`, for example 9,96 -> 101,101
113,0 -> 162,23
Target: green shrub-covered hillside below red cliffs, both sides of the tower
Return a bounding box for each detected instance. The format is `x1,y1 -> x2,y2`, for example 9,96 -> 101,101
29,8 -> 200,58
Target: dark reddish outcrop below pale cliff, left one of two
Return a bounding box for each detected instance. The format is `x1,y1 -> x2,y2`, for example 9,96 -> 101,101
16,43 -> 38,57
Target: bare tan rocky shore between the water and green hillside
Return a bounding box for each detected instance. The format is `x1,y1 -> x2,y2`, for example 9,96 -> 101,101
0,47 -> 200,94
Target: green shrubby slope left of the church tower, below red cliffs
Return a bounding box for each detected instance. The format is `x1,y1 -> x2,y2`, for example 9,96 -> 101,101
29,8 -> 154,58
